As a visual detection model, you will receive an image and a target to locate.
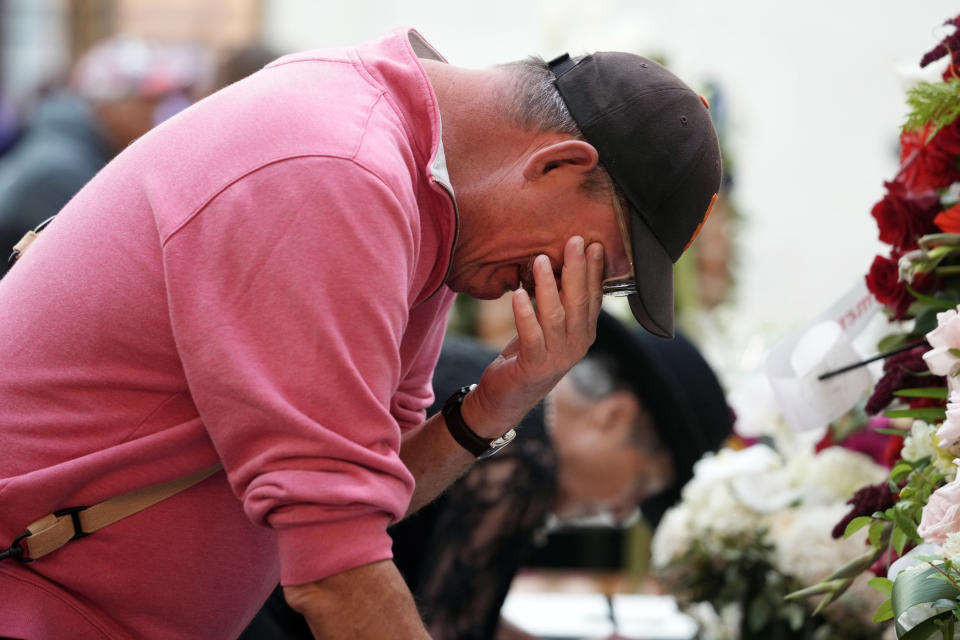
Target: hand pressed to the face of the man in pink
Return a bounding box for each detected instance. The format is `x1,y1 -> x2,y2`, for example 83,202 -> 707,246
462,236 -> 603,437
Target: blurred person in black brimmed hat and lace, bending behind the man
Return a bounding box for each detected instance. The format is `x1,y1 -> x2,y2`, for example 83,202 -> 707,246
241,312 -> 733,640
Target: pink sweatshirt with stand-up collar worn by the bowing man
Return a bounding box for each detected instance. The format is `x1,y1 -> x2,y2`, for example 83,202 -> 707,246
0,30 -> 456,639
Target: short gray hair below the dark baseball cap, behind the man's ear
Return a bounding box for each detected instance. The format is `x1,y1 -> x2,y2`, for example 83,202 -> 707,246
500,56 -> 612,200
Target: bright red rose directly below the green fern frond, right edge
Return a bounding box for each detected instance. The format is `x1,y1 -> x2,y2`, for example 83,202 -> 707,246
897,121 -> 960,193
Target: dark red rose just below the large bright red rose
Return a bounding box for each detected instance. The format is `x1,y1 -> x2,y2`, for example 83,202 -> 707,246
871,182 -> 940,250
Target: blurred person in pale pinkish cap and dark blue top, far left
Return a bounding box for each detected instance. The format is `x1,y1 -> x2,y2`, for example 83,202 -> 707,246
0,36 -> 195,275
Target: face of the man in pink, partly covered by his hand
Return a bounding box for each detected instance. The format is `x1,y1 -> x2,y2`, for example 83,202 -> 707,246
447,180 -> 630,300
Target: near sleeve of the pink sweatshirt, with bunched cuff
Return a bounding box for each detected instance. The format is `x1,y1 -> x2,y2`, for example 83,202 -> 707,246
163,157 -> 419,584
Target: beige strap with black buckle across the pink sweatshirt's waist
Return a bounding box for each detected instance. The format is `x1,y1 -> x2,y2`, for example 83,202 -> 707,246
19,464 -> 223,561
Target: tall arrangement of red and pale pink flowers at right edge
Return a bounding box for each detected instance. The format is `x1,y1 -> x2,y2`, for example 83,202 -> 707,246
793,16 -> 960,640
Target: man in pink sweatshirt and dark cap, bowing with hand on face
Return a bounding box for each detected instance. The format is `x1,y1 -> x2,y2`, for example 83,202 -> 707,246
0,30 -> 720,638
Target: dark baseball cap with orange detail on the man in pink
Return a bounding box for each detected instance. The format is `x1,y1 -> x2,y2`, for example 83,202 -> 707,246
548,52 -> 721,338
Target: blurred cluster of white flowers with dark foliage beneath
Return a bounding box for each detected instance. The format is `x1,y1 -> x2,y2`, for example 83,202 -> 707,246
652,443 -> 887,640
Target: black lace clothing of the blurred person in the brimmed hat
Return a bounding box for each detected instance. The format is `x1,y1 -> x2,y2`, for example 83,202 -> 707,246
241,337 -> 556,640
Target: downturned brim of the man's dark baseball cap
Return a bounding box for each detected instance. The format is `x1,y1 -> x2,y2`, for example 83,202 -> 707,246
627,206 -> 674,338
